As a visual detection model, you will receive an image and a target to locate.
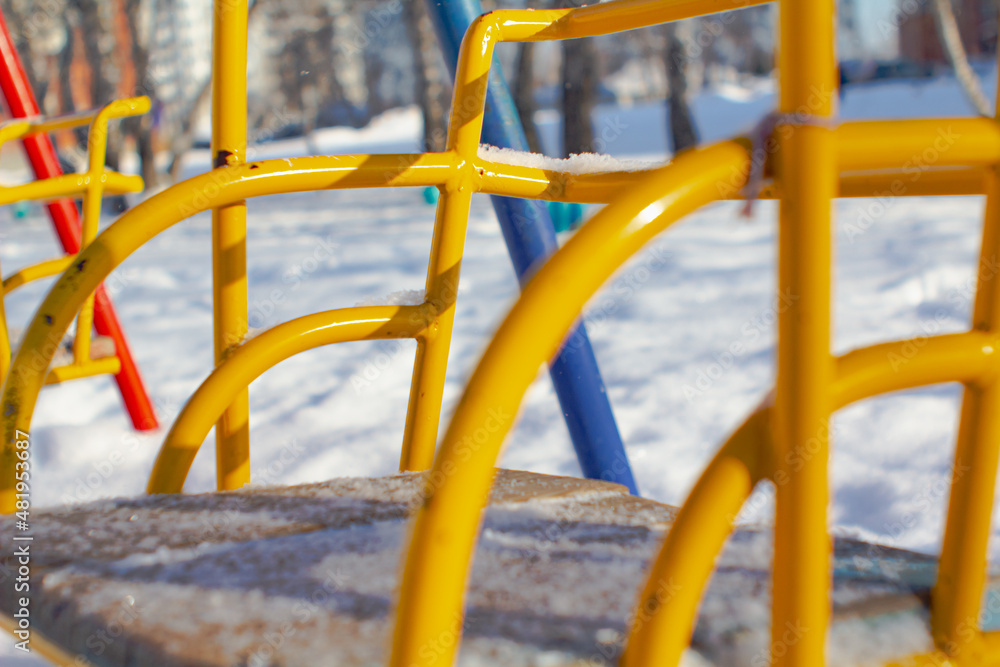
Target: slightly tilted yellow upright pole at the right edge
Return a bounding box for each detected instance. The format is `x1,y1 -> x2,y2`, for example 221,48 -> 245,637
931,77 -> 1000,655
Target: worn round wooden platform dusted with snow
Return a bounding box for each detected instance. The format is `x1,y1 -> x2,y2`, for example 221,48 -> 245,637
0,470 -> 984,667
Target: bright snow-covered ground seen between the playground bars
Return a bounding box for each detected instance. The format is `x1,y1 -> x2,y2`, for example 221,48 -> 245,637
0,69 -> 1000,667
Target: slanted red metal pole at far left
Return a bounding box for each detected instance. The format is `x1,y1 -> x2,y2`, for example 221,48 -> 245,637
0,11 -> 158,431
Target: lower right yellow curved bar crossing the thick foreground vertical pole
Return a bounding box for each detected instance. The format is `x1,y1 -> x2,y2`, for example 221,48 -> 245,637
622,331 -> 1000,667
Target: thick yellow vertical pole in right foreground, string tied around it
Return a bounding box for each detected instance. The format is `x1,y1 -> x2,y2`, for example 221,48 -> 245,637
771,0 -> 838,667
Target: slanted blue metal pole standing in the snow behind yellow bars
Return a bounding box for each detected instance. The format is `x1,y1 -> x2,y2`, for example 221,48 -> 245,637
427,0 -> 639,495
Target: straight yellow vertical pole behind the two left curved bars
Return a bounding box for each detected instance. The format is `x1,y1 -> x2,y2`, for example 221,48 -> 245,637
212,0 -> 250,489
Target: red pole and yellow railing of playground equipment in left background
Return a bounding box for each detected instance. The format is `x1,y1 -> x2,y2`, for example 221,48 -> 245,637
0,13 -> 158,431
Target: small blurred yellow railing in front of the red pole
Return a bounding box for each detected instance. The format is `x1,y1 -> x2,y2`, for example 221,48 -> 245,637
0,97 -> 150,384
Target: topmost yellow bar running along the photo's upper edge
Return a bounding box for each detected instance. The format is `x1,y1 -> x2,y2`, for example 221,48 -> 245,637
485,0 -> 770,42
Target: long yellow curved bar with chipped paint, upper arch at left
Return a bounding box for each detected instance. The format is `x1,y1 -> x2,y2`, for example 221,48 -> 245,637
0,154 -> 456,514
